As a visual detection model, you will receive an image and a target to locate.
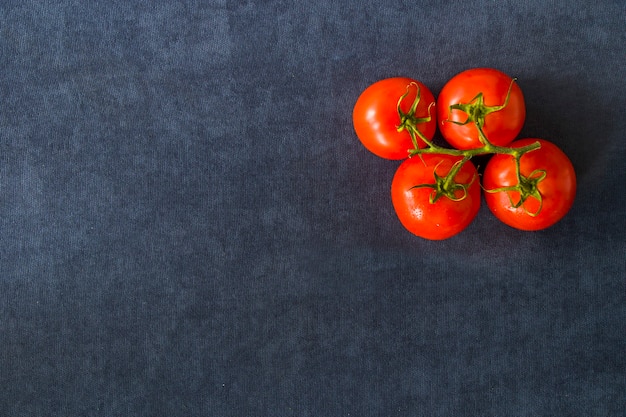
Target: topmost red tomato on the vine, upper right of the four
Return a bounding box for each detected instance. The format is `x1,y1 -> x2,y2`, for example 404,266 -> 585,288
437,68 -> 526,149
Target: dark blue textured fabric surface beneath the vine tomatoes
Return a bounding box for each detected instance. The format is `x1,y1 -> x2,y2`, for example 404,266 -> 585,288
0,0 -> 626,417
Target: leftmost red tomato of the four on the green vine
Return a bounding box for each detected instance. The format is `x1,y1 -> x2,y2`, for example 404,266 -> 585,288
352,77 -> 437,160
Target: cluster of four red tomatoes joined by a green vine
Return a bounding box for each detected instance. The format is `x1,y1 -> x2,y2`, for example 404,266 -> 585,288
353,68 -> 576,240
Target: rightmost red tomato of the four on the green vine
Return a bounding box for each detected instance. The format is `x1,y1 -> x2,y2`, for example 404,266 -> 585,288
483,139 -> 576,230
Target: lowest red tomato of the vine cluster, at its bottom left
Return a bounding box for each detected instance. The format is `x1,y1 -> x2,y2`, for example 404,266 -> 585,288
391,154 -> 480,240
